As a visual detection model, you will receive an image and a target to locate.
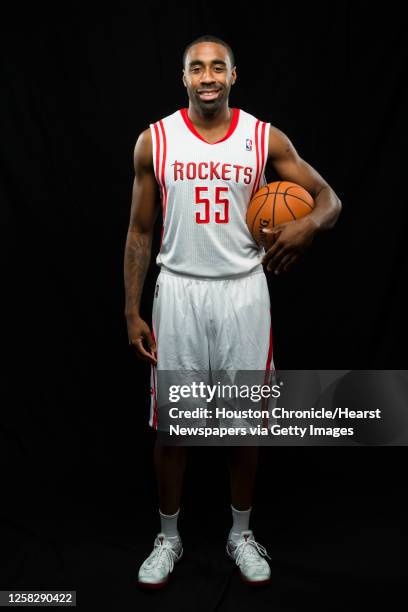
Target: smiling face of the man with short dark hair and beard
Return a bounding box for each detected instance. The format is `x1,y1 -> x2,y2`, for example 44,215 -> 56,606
183,42 -> 237,115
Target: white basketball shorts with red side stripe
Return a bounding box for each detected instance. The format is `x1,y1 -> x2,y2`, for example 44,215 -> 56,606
149,268 -> 274,429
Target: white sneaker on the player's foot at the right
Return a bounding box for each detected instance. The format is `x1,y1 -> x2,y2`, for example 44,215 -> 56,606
226,530 -> 271,586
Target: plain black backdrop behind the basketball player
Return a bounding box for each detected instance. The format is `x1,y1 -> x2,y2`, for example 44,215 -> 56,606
0,1 -> 407,611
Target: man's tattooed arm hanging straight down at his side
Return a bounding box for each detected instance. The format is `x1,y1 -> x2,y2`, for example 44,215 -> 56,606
124,129 -> 159,363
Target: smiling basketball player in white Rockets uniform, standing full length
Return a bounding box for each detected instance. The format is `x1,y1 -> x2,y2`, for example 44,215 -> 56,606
124,35 -> 341,588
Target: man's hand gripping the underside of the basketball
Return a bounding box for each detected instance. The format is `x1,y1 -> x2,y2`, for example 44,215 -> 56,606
261,215 -> 318,274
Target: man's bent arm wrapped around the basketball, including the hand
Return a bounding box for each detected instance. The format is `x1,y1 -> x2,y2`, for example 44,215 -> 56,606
264,126 -> 342,274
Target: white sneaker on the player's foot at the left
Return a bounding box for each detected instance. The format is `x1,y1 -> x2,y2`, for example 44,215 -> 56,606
138,533 -> 183,589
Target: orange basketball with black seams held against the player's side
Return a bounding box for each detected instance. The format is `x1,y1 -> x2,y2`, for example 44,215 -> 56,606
246,181 -> 315,244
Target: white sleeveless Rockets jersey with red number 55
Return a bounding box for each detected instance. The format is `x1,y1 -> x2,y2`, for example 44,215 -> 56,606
150,108 -> 270,278
